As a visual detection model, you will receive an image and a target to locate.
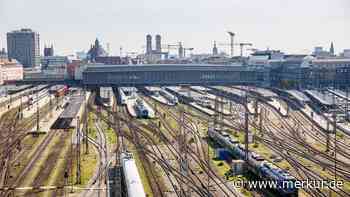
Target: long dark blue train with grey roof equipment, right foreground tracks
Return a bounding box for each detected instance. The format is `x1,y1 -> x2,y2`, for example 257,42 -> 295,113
208,128 -> 298,196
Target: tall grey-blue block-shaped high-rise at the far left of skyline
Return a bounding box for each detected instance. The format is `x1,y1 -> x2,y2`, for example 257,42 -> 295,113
7,29 -> 40,68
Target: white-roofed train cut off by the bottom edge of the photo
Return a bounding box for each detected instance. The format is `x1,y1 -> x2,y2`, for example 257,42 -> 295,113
120,152 -> 146,197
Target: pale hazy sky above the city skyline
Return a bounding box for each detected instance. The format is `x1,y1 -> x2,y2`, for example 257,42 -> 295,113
0,0 -> 350,55
